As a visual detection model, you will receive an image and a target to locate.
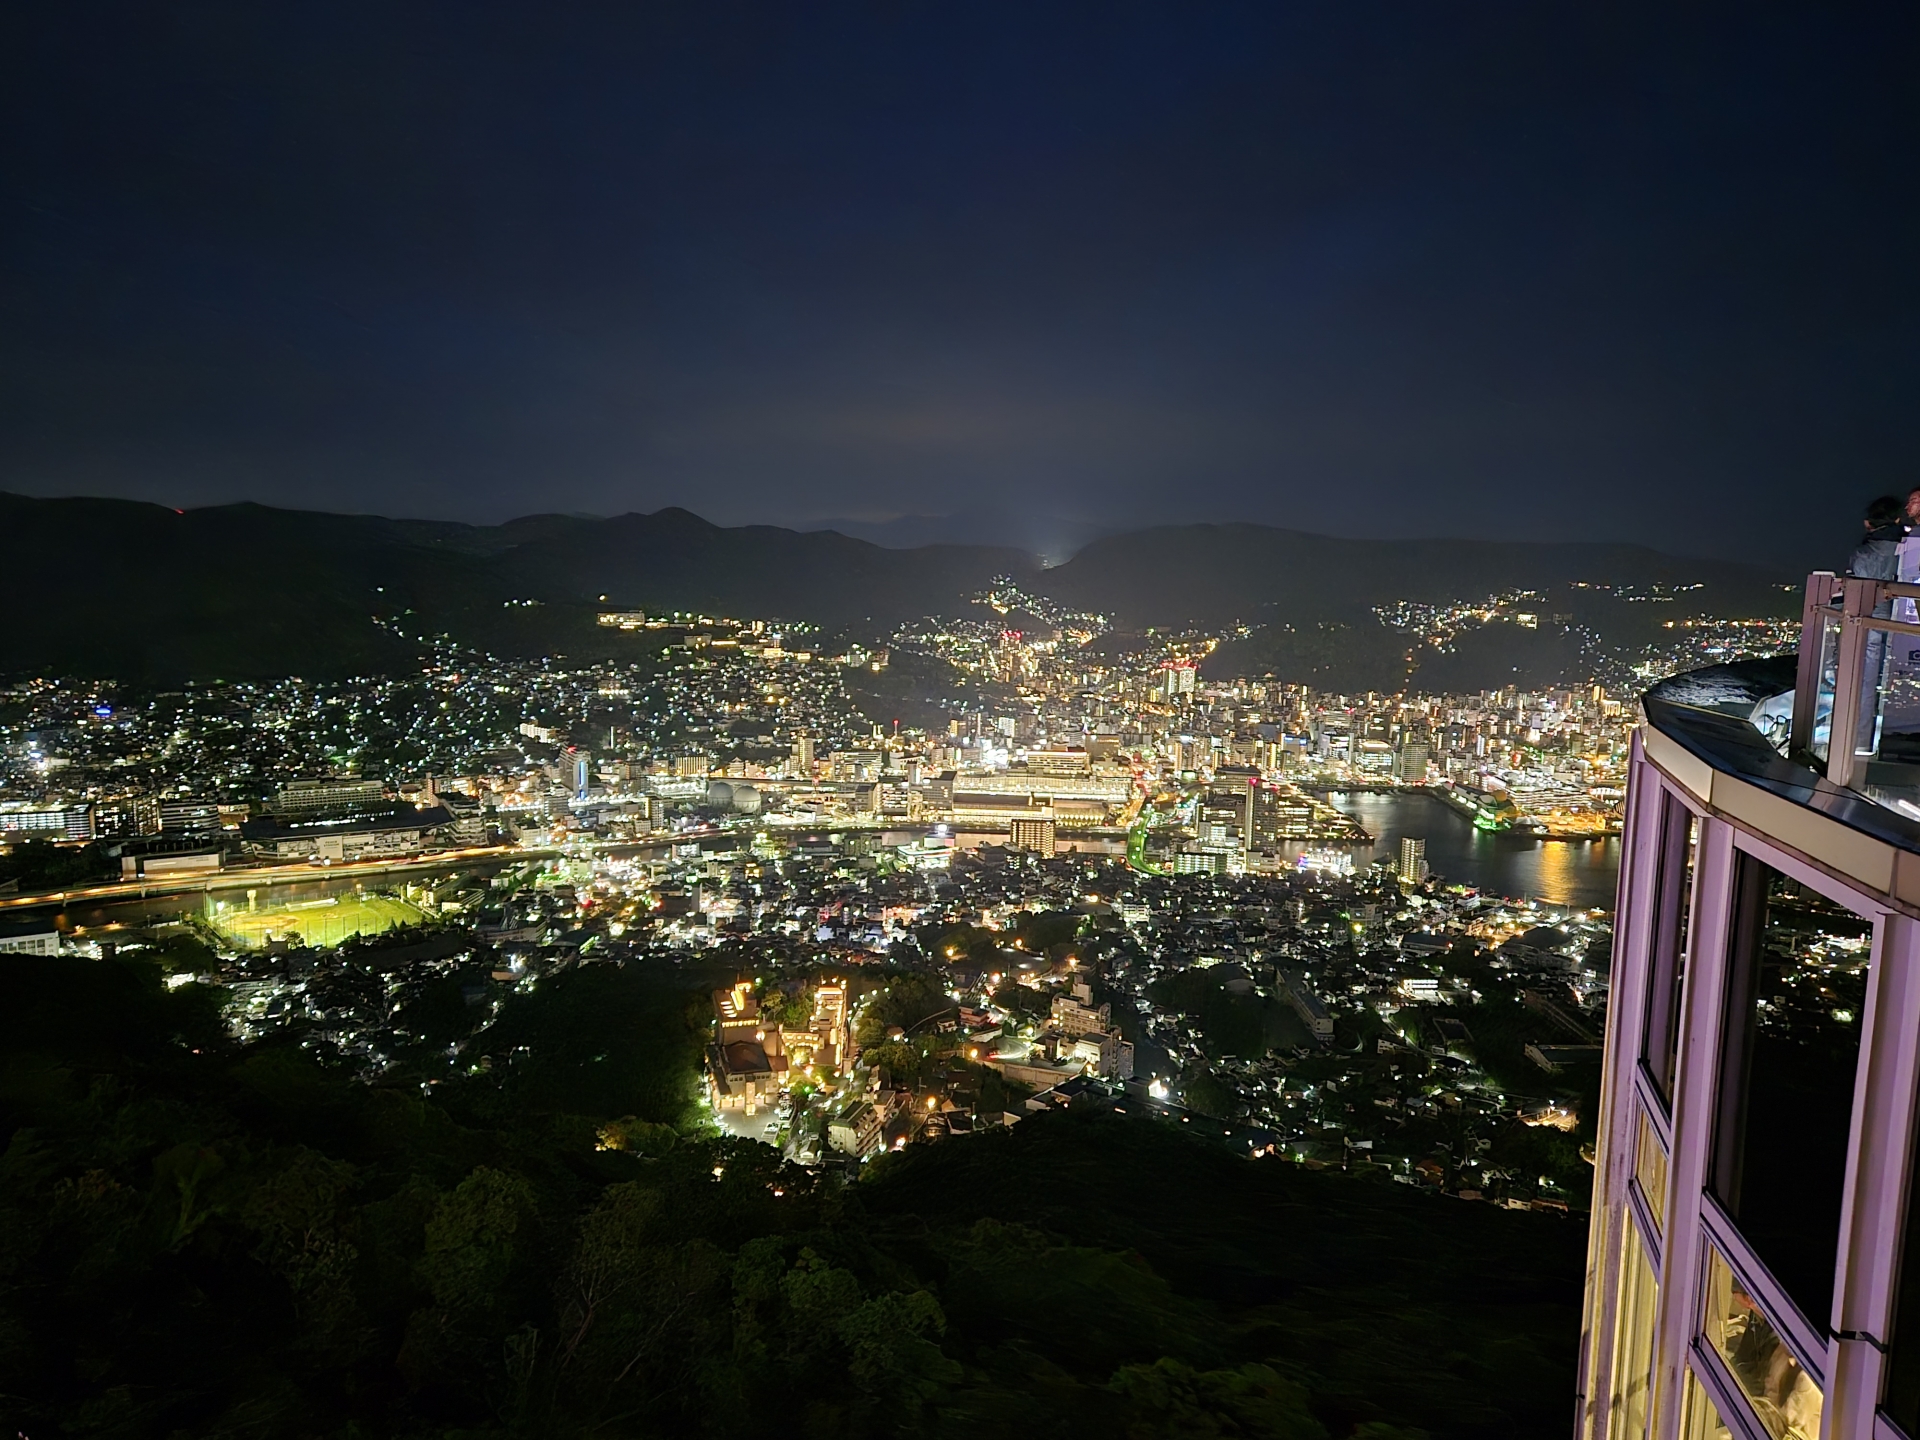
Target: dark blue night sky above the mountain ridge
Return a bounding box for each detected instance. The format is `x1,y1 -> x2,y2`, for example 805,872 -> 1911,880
0,0 -> 1920,563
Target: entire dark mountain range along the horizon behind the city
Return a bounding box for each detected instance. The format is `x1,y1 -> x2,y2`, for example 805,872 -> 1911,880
0,492 -> 1786,682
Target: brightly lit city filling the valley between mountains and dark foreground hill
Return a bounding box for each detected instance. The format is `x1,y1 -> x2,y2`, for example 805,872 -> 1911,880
0,582 -> 1797,1208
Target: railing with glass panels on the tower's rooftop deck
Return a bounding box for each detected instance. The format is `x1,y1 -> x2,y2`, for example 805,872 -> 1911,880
1784,570 -> 1920,818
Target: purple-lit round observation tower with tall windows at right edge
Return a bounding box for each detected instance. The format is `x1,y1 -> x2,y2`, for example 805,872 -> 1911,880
1578,574 -> 1920,1440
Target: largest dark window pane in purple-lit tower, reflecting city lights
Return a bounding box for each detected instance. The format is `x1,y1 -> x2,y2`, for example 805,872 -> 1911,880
1713,856 -> 1874,1325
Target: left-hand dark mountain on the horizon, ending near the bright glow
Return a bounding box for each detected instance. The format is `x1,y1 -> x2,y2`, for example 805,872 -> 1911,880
0,493 -> 1039,680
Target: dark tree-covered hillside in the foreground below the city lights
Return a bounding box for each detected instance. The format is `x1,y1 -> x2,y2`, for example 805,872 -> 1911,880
0,952 -> 1584,1440
